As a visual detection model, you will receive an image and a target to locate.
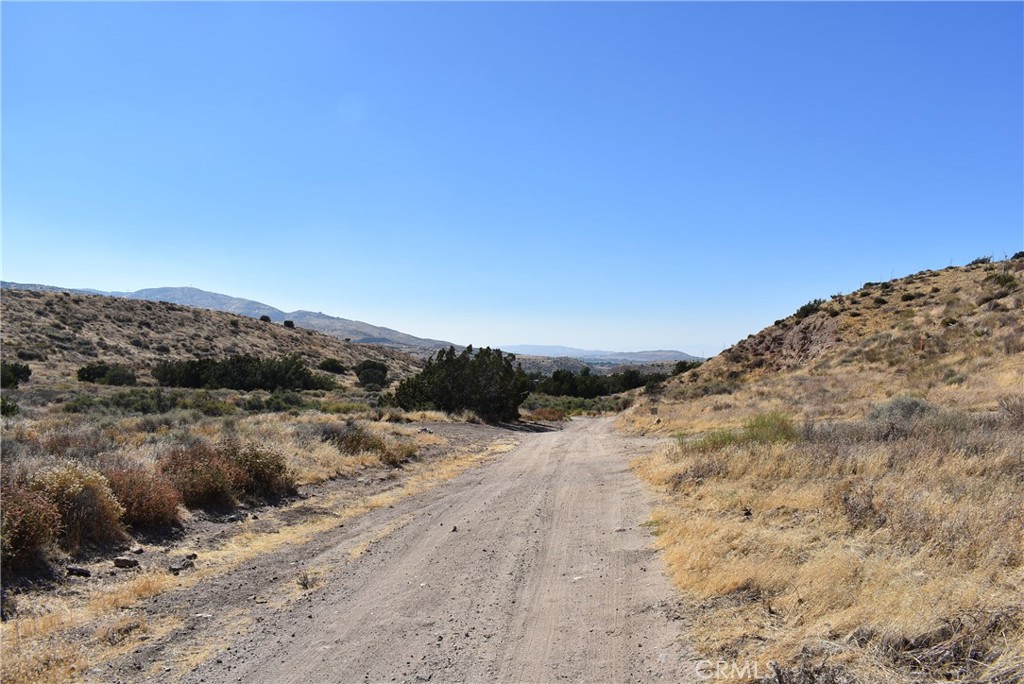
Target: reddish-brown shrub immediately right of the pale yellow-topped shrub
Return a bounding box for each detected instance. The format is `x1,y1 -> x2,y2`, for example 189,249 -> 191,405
103,465 -> 181,529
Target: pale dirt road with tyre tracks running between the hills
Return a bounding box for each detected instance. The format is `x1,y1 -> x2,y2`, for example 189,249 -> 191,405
186,419 -> 694,684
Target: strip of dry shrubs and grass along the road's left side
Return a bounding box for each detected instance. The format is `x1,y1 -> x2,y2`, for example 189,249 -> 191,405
0,404 -> 436,584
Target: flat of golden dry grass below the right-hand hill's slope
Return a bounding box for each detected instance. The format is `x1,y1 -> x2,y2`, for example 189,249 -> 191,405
633,395 -> 1024,683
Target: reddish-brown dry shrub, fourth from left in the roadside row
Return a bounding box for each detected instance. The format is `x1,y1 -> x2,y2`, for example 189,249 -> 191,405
158,439 -> 246,508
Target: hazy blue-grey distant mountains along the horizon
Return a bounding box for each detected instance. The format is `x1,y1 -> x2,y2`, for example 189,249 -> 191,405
0,281 -> 696,366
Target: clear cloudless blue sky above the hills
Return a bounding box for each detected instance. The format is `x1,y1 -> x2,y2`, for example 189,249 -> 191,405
0,2 -> 1024,354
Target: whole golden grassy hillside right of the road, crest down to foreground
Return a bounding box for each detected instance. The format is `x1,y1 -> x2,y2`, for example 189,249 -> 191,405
622,255 -> 1024,684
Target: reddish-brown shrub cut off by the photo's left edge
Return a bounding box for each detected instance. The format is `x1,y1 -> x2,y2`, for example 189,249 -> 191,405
0,479 -> 60,570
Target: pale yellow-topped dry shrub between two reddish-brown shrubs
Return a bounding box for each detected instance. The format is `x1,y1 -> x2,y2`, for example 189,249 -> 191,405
31,462 -> 125,553
